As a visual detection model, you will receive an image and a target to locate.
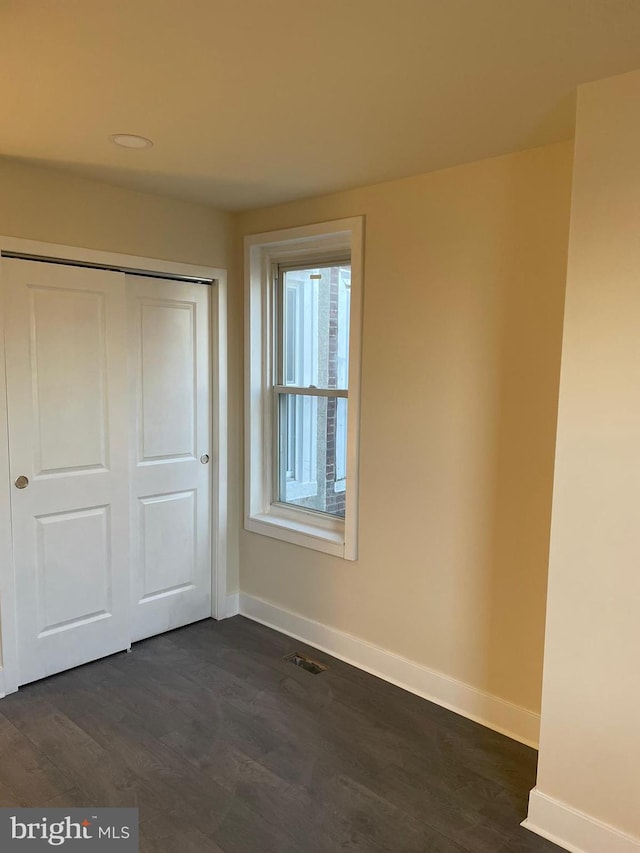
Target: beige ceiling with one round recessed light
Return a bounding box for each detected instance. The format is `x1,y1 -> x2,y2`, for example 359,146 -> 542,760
0,0 -> 640,210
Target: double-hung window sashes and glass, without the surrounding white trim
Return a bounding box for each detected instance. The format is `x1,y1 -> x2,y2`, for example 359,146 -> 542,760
273,257 -> 351,518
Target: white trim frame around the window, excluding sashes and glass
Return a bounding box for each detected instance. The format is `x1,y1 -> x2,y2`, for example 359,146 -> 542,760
244,216 -> 364,560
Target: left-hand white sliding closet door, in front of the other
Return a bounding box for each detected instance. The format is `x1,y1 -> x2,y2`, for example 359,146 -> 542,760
2,259 -> 130,684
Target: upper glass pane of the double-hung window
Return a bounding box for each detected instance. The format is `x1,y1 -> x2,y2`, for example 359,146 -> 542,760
282,264 -> 351,388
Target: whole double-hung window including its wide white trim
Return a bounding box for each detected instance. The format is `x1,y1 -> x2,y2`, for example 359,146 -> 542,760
245,218 -> 362,559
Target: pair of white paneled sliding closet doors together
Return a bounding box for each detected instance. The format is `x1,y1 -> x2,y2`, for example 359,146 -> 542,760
2,259 -> 213,684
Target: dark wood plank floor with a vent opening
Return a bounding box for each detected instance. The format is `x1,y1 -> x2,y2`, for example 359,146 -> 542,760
0,616 -> 560,853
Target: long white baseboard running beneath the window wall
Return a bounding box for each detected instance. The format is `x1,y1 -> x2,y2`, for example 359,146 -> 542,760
240,592 -> 540,748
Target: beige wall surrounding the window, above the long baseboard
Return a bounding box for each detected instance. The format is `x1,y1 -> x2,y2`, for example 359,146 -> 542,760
237,143 -> 572,711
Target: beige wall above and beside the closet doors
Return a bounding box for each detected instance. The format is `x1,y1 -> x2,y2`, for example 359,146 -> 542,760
0,158 -> 241,591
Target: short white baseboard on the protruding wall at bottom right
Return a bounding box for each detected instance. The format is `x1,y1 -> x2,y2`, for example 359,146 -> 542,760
522,788 -> 640,853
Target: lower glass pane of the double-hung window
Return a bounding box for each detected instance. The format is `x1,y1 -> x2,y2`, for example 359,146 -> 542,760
278,394 -> 347,518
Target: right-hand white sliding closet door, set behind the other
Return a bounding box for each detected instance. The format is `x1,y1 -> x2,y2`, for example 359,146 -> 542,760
127,276 -> 213,641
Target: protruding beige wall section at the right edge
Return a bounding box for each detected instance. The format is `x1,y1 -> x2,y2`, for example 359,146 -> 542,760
538,72 -> 640,840
